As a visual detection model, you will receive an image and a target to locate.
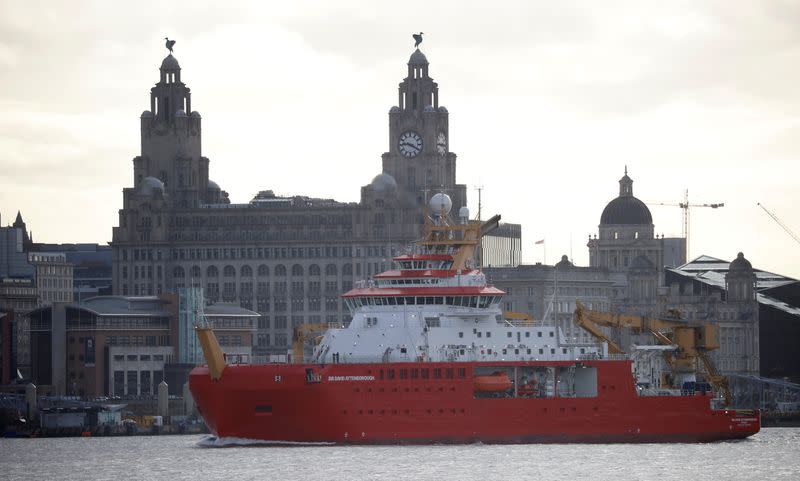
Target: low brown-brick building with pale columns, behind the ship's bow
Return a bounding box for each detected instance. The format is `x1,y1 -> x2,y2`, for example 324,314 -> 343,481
30,294 -> 259,398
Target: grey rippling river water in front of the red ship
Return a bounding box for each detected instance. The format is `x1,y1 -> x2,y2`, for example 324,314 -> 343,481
0,428 -> 800,481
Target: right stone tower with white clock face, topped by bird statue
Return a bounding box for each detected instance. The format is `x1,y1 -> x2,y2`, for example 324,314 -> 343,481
382,49 -> 467,207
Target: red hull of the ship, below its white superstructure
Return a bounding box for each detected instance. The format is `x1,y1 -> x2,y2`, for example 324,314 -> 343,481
190,360 -> 760,444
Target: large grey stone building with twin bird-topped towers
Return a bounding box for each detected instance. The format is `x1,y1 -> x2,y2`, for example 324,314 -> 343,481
111,50 -> 524,355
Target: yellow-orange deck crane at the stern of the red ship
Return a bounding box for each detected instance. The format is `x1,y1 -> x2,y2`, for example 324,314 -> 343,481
575,300 -> 731,406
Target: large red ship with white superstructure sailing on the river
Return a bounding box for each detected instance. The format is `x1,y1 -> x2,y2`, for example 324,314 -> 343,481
190,194 -> 760,444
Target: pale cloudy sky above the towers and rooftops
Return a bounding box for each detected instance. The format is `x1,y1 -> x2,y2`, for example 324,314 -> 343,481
0,1 -> 800,276
